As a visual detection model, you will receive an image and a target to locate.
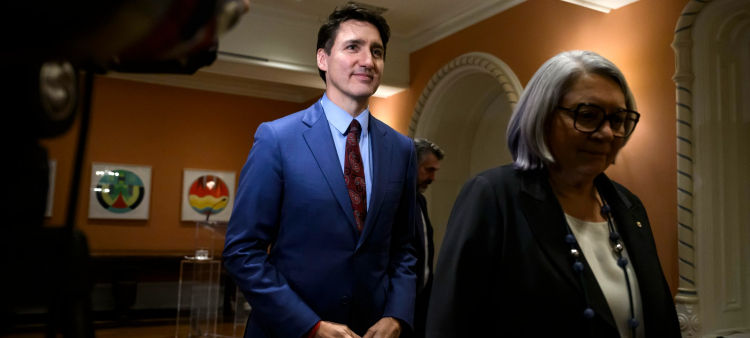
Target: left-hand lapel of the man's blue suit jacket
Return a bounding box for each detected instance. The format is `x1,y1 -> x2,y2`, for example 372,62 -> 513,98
302,102 -> 357,231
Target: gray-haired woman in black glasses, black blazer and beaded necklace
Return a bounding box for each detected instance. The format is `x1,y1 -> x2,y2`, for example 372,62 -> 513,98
427,51 -> 680,338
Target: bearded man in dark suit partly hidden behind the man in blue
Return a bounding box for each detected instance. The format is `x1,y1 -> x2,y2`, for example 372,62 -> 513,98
404,138 -> 445,338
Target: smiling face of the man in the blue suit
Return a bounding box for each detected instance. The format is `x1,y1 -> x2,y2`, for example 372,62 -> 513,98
318,20 -> 385,102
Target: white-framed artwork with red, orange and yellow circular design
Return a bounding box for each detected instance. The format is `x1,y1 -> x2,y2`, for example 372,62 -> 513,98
182,169 -> 235,222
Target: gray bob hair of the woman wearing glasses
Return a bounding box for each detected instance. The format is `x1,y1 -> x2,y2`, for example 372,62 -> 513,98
507,50 -> 636,170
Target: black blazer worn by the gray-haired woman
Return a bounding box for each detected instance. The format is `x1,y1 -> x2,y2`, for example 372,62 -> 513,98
427,165 -> 680,338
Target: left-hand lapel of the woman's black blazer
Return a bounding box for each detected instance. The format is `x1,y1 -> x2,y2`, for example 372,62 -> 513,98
520,170 -> 617,330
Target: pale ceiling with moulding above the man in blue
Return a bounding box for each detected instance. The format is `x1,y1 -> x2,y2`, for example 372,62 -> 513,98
107,0 -> 637,103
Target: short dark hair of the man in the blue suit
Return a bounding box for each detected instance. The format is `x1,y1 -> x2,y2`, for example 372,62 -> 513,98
315,4 -> 391,82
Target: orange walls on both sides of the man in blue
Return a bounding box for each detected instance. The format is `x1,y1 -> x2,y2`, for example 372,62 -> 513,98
39,0 -> 689,292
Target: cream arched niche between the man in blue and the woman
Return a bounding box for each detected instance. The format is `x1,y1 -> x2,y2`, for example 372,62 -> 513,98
409,53 -> 523,262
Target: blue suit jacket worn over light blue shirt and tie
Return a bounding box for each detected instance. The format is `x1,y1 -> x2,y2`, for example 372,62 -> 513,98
223,102 -> 424,338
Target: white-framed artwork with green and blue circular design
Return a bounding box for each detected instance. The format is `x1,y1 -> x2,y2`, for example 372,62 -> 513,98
89,163 -> 151,219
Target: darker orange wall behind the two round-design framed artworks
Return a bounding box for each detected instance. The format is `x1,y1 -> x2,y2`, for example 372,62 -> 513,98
43,77 -> 306,252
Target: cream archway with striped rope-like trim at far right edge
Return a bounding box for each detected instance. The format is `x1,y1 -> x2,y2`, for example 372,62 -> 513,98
672,0 -> 750,337
